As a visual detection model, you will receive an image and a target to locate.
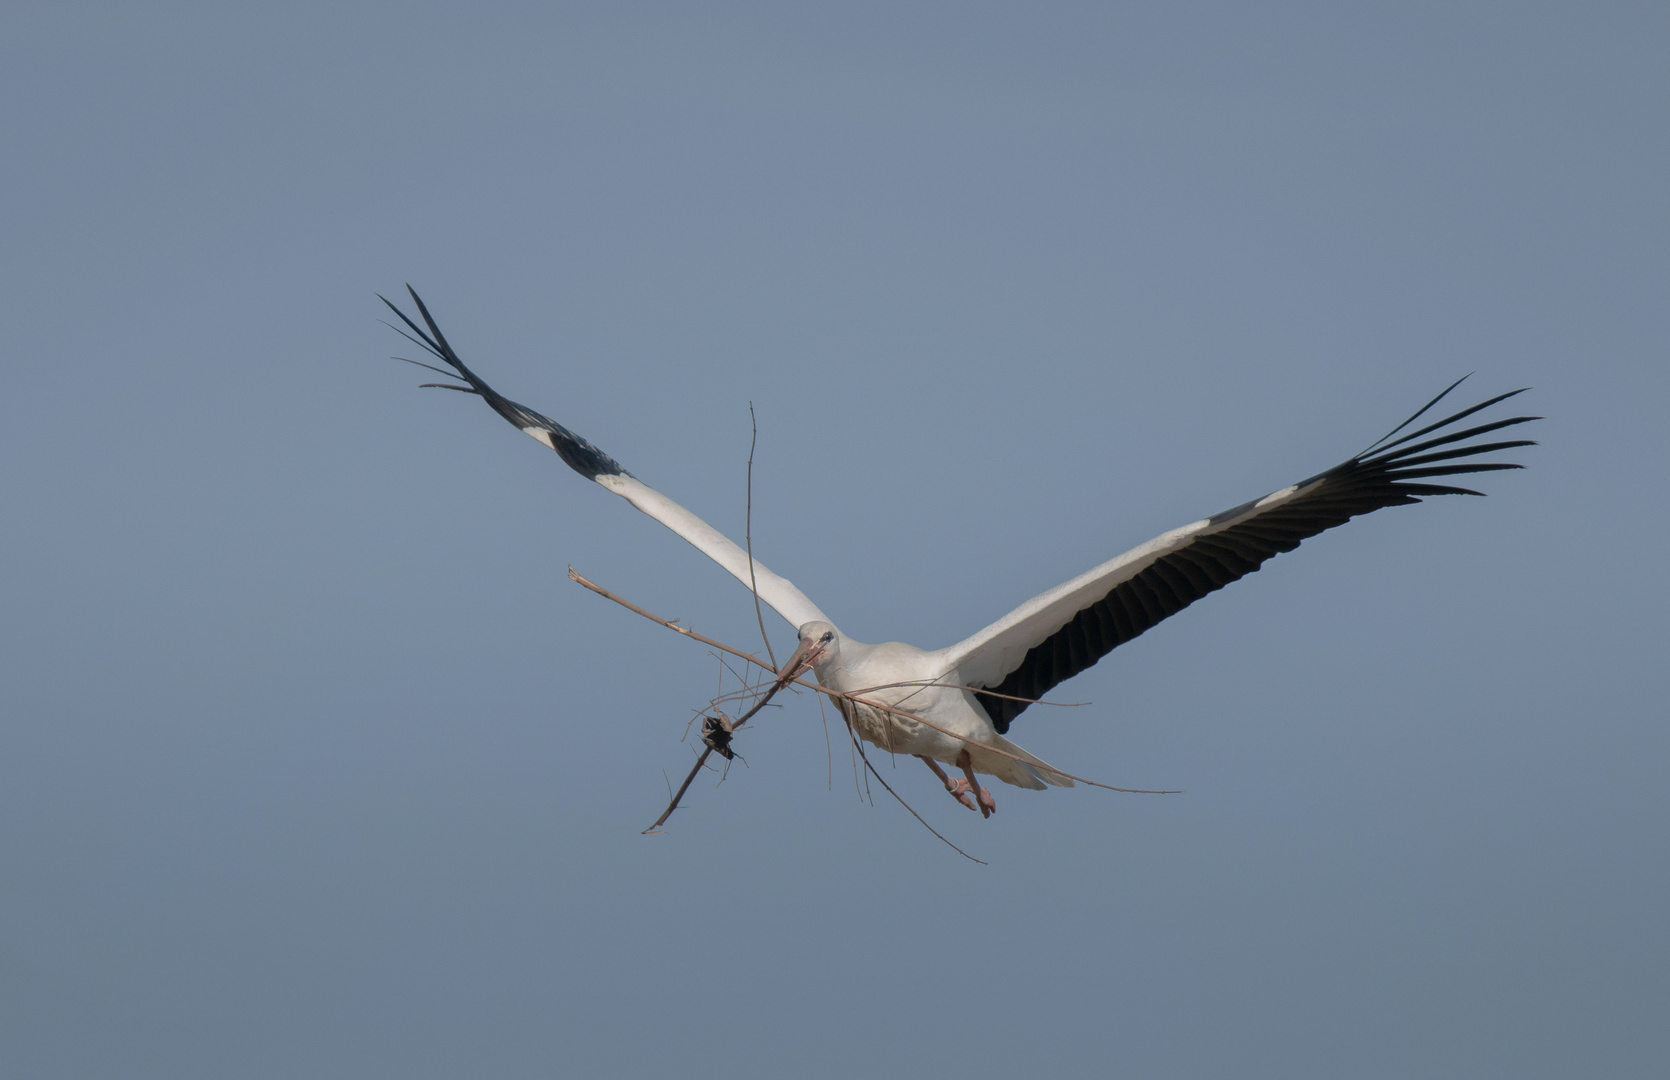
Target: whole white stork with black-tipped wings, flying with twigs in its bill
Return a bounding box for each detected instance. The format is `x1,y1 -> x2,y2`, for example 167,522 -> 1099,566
377,285 -> 1541,816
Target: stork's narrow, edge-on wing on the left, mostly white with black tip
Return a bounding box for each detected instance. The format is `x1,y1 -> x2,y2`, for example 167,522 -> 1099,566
377,285 -> 827,628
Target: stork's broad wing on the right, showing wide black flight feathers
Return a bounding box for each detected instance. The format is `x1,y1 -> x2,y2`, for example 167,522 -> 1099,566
942,376 -> 1541,731
